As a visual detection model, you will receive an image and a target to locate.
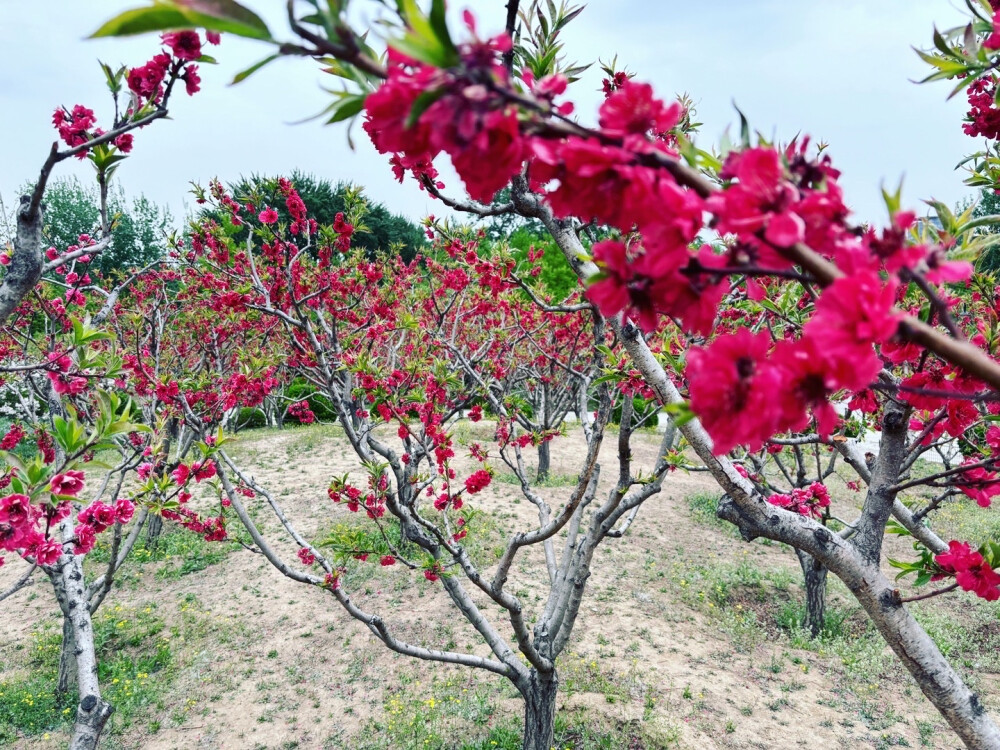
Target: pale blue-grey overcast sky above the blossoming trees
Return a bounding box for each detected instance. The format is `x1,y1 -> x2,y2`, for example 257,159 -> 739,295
0,0 -> 977,231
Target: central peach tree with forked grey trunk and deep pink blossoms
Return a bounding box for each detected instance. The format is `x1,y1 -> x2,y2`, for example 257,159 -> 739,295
124,172 -> 671,747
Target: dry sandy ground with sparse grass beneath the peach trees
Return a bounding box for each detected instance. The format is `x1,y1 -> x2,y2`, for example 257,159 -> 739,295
0,429 -> 1000,750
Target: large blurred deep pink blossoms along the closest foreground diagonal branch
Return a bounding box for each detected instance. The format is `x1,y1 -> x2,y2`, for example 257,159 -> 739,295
356,16 -> 971,453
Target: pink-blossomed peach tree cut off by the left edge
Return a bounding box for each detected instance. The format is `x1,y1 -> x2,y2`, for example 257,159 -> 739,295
0,31 -> 218,748
